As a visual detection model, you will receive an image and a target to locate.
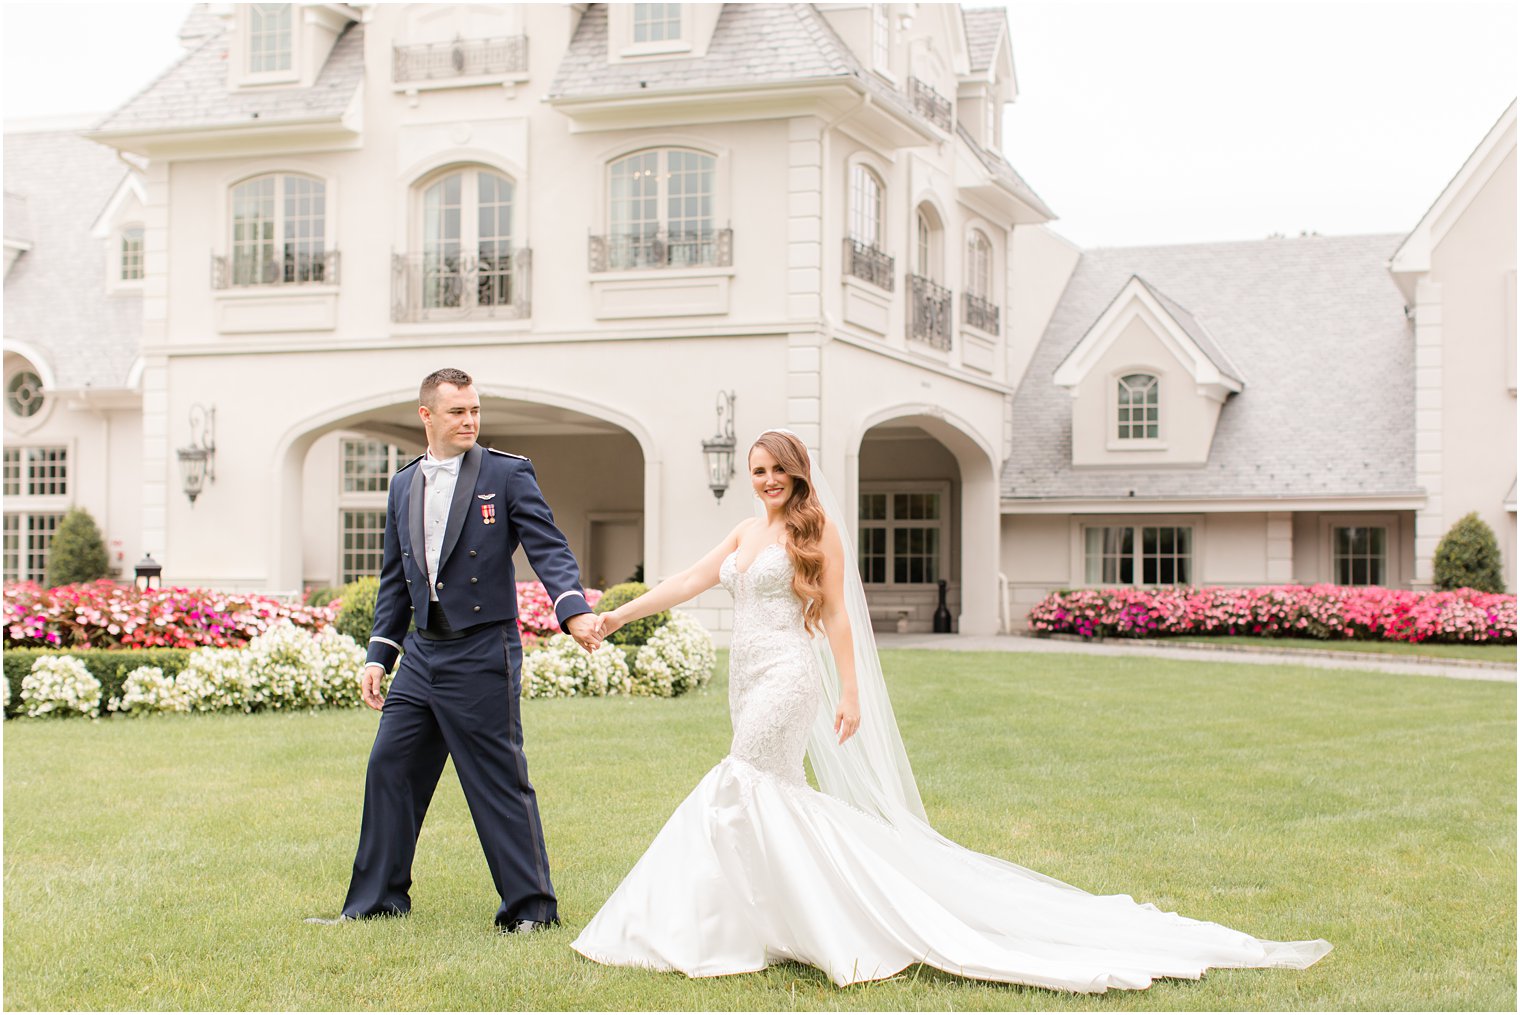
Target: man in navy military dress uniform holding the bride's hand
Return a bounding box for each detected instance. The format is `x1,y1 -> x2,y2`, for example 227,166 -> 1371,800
312,369 -> 600,933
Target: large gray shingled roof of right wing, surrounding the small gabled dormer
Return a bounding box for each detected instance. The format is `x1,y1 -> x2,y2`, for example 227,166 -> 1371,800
1002,236 -> 1418,501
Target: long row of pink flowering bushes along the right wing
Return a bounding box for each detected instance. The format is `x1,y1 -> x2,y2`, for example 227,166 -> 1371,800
1029,585 -> 1515,644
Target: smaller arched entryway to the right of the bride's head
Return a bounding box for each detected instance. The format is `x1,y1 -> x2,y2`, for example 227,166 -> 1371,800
853,409 -> 999,634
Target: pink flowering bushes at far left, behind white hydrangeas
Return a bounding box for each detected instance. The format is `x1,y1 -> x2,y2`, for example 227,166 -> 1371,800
5,580 -> 336,649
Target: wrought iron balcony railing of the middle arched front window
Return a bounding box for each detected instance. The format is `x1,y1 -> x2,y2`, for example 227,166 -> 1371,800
391,248 -> 534,322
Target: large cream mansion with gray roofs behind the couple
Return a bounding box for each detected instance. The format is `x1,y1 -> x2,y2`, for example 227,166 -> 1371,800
5,3 -> 1515,634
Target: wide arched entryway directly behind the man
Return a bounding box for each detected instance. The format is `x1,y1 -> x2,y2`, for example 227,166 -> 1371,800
275,389 -> 651,588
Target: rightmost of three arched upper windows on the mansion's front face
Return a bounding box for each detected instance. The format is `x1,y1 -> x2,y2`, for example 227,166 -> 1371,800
608,147 -> 725,270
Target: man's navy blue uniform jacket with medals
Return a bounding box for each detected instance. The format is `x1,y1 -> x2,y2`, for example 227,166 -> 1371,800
366,445 -> 591,672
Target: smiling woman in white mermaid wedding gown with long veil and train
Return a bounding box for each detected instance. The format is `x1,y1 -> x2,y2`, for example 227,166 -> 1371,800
572,430 -> 1330,992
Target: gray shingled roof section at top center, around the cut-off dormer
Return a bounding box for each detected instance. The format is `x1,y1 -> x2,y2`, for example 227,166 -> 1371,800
549,3 -> 923,127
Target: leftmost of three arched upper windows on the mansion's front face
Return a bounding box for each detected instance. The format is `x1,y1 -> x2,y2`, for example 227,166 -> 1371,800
231,173 -> 331,286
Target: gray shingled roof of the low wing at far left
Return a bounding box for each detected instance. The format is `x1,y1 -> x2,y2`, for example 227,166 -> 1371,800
5,131 -> 143,387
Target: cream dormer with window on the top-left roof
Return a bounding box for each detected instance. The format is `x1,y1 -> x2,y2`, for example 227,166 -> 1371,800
220,3 -> 360,90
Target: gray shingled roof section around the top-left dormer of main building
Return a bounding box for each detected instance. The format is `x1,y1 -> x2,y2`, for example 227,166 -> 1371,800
94,18 -> 365,132
